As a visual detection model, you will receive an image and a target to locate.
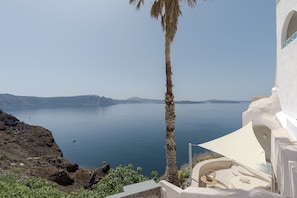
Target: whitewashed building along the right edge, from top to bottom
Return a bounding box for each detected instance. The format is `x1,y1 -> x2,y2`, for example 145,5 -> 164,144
242,0 -> 297,198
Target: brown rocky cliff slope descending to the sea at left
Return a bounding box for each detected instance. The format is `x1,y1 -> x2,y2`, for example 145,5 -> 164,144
0,109 -> 109,191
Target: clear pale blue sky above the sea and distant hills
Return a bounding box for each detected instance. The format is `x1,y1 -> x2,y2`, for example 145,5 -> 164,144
0,0 -> 276,101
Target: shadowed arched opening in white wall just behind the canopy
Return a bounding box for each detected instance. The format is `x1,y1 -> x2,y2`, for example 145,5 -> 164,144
253,125 -> 271,162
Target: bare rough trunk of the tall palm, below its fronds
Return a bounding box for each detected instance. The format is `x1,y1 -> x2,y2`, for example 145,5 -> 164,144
165,32 -> 179,186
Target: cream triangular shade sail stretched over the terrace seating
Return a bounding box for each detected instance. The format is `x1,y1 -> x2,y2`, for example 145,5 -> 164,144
199,122 -> 267,173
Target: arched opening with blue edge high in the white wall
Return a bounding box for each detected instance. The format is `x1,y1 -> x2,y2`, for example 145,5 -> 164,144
282,11 -> 297,48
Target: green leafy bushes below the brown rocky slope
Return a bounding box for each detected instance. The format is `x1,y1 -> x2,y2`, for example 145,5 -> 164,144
0,164 -> 149,198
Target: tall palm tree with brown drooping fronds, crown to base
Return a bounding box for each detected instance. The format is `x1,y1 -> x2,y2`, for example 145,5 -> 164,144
130,0 -> 196,185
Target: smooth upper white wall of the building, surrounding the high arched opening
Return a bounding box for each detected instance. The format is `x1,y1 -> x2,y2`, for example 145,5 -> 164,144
275,0 -> 297,119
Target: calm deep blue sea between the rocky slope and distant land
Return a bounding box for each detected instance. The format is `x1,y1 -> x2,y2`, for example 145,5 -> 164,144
9,102 -> 249,176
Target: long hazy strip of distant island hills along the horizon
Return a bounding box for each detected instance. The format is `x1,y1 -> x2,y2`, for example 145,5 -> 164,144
0,94 -> 250,110
